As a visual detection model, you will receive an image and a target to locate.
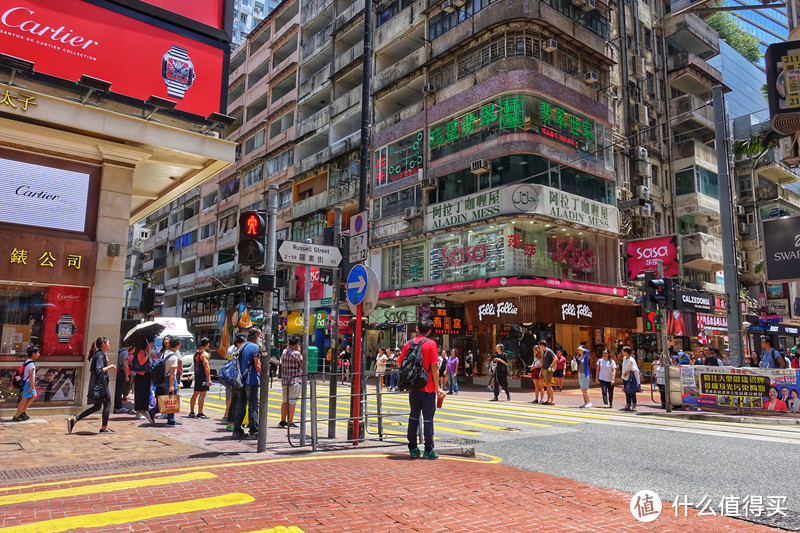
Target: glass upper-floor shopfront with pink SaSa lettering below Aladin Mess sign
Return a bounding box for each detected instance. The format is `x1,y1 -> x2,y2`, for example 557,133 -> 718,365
382,220 -> 618,290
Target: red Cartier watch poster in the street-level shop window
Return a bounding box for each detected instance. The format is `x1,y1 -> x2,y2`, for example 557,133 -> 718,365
41,286 -> 89,355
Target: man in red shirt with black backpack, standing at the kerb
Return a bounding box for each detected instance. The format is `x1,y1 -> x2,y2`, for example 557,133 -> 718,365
397,318 -> 446,459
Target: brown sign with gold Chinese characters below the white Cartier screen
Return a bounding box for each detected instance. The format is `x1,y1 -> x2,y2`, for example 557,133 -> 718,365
0,230 -> 97,287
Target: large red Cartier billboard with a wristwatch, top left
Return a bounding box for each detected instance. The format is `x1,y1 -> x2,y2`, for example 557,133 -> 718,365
0,0 -> 227,116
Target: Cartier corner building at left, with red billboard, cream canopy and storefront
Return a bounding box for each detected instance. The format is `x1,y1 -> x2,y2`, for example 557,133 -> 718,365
0,0 -> 235,416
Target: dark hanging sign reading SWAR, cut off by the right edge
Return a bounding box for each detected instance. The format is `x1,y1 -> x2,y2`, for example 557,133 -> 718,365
761,215 -> 800,282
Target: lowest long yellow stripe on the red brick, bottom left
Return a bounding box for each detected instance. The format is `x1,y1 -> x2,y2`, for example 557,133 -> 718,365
0,492 -> 255,533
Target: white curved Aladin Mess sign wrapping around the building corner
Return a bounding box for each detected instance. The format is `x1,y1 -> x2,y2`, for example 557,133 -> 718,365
425,184 -> 619,233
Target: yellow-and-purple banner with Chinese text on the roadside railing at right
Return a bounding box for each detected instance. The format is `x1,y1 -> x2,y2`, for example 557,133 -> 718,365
680,366 -> 800,415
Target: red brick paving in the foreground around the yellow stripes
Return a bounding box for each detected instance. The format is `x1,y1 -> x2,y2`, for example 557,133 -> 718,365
0,454 -> 784,533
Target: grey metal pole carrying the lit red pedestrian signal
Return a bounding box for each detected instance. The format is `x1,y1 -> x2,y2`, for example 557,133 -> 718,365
256,183 -> 278,453
